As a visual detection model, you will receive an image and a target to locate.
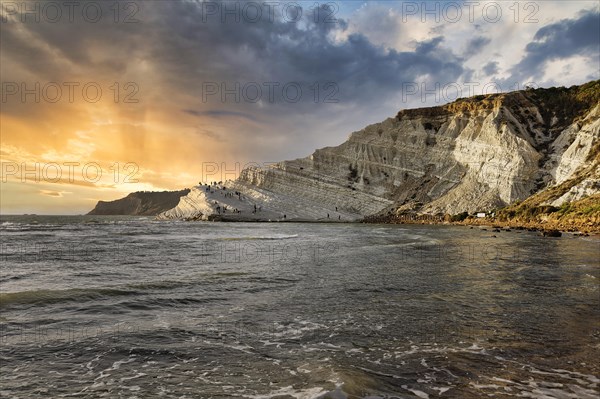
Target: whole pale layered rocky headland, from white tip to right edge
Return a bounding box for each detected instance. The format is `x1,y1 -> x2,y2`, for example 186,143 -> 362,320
89,81 -> 600,231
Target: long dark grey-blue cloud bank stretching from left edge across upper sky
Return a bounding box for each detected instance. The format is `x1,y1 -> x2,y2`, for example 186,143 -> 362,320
2,1 -> 464,112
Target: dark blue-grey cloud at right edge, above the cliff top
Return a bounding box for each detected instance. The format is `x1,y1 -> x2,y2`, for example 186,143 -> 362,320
511,9 -> 600,81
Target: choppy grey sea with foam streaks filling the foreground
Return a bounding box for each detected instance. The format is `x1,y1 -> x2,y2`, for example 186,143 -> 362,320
0,216 -> 600,399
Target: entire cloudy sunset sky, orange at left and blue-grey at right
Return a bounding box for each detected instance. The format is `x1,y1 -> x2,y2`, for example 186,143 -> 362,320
0,0 -> 600,214
